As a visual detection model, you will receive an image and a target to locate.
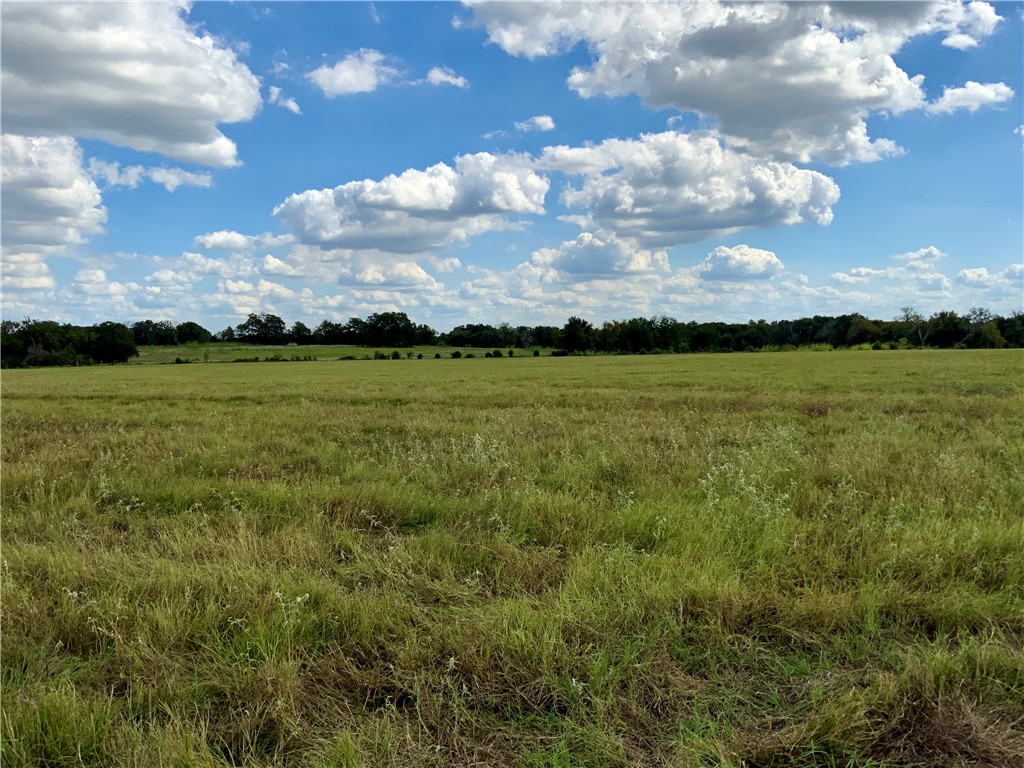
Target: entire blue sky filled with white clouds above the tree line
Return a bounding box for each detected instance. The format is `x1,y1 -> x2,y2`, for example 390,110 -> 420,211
0,0 -> 1024,332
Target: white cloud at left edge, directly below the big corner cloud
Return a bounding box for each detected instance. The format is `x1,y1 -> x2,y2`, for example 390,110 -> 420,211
0,134 -> 106,290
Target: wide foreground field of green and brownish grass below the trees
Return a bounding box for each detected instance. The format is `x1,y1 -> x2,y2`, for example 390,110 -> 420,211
2,350 -> 1024,768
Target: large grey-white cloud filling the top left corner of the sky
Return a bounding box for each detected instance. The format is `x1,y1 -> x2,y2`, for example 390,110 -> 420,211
2,2 -> 261,167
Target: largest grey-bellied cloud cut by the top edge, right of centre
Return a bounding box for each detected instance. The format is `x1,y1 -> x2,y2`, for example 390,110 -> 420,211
472,0 -> 999,165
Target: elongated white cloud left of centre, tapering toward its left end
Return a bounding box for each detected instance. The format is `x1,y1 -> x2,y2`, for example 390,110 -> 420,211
273,153 -> 550,254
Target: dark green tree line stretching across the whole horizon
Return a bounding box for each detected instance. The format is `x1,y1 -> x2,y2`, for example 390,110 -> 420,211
0,307 -> 1024,368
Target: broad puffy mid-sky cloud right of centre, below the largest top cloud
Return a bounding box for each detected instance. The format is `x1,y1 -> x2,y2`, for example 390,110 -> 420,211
538,131 -> 840,248
